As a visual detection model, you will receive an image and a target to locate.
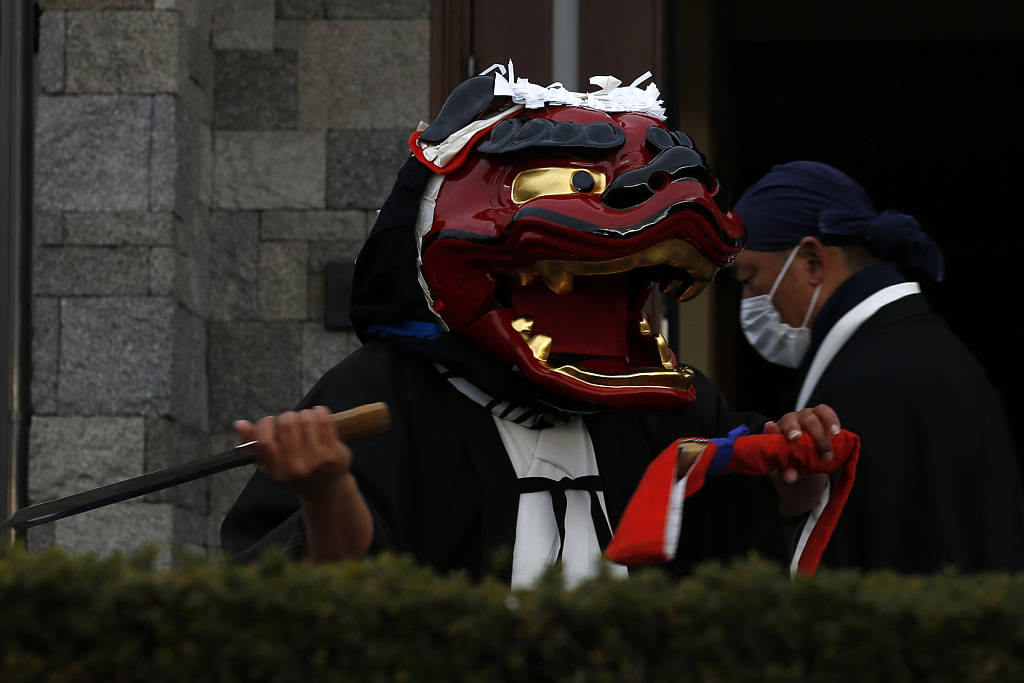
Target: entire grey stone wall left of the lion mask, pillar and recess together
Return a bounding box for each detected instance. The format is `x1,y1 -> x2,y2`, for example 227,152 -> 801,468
29,0 -> 430,561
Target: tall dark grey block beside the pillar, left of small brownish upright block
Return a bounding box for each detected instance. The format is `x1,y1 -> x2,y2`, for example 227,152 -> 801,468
210,211 -> 259,321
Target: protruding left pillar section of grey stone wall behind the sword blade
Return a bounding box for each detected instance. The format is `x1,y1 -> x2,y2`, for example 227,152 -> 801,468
29,0 -> 213,562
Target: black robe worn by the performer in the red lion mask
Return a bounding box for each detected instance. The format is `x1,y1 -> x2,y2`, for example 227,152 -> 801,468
221,342 -> 784,579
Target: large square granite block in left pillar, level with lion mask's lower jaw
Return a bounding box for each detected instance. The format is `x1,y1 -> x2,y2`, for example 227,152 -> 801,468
57,297 -> 175,415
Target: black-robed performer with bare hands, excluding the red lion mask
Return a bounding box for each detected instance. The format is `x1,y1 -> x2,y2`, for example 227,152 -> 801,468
221,77 -> 839,581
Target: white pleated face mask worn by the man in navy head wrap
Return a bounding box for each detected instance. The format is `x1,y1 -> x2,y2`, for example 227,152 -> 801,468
739,245 -> 821,368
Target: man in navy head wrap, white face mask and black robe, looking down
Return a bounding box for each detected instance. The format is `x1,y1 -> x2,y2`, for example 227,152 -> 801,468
734,161 -> 1024,572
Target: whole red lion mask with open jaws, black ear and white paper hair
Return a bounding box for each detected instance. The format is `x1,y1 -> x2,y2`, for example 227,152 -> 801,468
401,65 -> 744,409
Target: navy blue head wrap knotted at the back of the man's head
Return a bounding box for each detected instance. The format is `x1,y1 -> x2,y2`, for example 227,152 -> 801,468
733,161 -> 944,281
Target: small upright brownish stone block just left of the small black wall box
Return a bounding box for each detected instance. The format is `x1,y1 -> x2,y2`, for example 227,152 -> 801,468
259,242 -> 308,321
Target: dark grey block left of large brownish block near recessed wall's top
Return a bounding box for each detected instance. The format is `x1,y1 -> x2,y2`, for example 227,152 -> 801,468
213,50 -> 297,130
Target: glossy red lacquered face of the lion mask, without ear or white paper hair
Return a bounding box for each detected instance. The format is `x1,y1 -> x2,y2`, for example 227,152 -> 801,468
422,106 -> 743,408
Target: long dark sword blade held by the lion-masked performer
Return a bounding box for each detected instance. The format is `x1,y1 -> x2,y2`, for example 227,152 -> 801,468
3,441 -> 256,530
